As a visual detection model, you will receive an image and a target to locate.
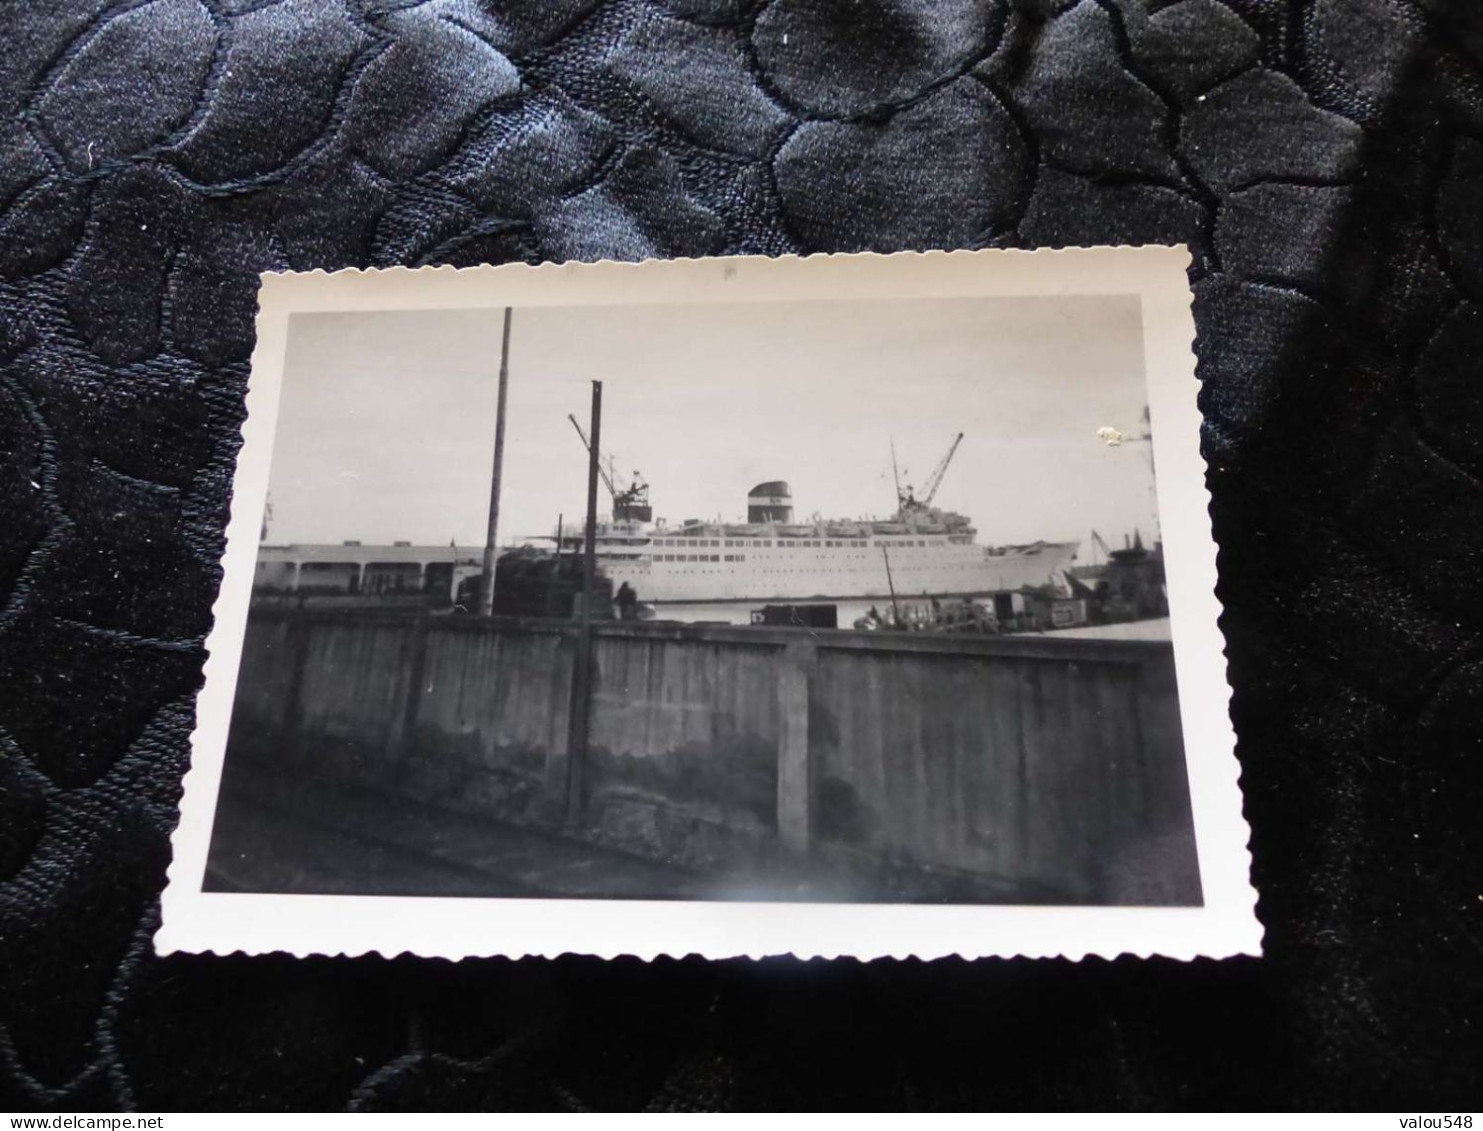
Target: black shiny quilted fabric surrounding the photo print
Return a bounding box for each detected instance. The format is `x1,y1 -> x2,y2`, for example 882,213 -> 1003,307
0,0 -> 1483,1110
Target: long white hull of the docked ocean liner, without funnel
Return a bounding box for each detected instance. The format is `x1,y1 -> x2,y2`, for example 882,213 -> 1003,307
599,538 -> 1077,605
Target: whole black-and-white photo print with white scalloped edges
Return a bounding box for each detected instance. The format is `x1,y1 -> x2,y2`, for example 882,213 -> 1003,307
156,248 -> 1261,959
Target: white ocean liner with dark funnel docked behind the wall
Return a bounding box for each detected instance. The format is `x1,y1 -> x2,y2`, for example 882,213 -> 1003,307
556,432 -> 1077,603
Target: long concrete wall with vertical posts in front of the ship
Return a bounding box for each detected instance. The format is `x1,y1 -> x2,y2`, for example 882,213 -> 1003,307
224,608 -> 1200,904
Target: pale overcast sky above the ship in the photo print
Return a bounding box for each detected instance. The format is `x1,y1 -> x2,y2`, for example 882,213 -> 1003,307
268,298 -> 1154,556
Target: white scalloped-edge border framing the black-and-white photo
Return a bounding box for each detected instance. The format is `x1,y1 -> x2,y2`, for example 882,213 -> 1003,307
154,246 -> 1262,959
